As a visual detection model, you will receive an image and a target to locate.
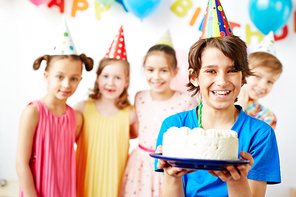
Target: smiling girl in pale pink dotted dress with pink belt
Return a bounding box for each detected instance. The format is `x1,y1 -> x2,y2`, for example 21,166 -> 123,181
119,44 -> 197,197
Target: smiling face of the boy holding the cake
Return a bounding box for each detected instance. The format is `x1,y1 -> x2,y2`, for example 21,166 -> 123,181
189,48 -> 243,110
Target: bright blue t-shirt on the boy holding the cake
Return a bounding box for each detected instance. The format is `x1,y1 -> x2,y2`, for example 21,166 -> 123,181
155,105 -> 281,197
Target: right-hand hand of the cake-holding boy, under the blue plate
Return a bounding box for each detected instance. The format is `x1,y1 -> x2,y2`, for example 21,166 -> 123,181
208,151 -> 254,182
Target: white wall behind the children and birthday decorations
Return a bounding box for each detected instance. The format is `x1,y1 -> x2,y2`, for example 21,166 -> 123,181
0,0 -> 296,197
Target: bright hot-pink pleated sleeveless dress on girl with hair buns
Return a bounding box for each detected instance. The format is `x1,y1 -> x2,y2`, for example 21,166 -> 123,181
19,100 -> 77,197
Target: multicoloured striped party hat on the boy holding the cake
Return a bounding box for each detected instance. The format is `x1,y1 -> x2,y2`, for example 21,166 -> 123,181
200,0 -> 233,39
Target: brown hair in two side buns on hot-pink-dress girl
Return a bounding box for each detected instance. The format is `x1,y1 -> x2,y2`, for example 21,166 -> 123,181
33,54 -> 94,71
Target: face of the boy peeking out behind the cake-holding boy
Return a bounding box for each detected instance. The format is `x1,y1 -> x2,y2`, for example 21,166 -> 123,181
244,66 -> 281,100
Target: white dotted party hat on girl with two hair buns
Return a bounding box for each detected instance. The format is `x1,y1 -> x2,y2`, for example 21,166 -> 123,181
51,17 -> 77,55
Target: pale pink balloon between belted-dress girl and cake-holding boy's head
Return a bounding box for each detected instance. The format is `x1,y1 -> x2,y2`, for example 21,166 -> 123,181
170,49 -> 189,92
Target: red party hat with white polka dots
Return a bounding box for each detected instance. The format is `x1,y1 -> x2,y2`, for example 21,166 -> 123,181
105,26 -> 127,61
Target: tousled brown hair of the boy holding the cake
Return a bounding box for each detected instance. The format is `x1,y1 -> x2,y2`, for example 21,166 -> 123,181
187,36 -> 252,96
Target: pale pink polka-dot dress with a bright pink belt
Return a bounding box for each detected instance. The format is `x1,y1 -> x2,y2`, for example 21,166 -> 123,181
119,90 -> 197,197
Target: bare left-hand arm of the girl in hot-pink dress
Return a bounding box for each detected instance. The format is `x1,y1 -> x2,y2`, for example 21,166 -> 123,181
16,105 -> 39,197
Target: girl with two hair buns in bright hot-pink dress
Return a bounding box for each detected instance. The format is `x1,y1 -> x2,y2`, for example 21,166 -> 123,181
16,18 -> 93,197
